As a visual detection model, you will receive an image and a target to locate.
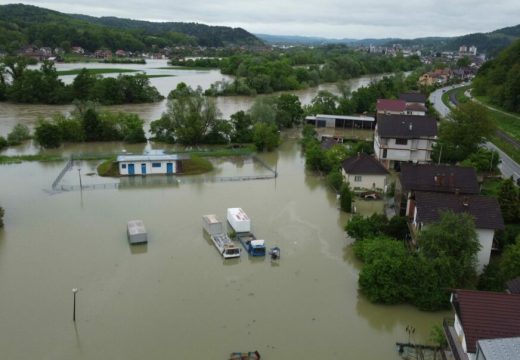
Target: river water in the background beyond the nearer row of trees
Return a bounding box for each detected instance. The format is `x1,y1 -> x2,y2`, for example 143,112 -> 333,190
0,60 -> 390,136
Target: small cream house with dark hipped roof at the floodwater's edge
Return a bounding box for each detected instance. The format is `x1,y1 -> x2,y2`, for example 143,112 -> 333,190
341,153 -> 388,192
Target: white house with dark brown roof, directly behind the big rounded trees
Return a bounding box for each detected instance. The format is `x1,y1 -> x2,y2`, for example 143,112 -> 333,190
408,191 -> 504,273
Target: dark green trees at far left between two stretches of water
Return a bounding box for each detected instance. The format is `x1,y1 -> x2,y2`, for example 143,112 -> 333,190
0,56 -> 163,105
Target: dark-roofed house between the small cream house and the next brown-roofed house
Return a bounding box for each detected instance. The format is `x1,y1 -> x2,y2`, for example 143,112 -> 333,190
395,163 -> 480,215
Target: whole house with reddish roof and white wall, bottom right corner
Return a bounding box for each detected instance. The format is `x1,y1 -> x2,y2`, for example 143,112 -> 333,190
444,290 -> 520,360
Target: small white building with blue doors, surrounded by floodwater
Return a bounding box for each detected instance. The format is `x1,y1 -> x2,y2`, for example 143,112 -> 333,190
117,154 -> 189,176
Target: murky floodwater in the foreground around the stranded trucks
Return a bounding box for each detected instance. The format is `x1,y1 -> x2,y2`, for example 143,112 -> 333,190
0,139 -> 446,360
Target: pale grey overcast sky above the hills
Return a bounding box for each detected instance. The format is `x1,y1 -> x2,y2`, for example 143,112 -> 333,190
4,0 -> 520,39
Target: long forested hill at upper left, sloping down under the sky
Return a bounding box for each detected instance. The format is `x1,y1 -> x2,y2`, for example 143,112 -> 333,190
0,4 -> 262,52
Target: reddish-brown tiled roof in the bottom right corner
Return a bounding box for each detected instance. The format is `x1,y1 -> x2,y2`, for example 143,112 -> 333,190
453,290 -> 520,353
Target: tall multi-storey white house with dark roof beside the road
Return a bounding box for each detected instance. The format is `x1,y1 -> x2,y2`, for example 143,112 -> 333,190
374,114 -> 437,169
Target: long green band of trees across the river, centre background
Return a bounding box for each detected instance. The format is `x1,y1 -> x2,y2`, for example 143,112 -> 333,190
202,45 -> 421,96
